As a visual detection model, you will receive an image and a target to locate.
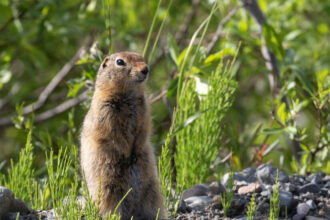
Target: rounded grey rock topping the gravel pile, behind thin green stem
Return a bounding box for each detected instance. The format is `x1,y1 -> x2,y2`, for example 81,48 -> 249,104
256,164 -> 289,185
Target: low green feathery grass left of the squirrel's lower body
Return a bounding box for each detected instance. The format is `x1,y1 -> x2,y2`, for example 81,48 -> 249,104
0,126 -> 123,220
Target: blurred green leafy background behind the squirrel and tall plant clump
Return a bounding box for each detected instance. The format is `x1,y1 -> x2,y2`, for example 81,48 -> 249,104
0,0 -> 330,176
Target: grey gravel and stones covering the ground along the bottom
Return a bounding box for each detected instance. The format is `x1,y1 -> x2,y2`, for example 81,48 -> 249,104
0,164 -> 330,220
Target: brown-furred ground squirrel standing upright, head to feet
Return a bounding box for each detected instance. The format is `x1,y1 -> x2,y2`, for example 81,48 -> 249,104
81,52 -> 164,219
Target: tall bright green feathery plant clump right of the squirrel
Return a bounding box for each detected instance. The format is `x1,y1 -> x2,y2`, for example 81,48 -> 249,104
159,1 -> 238,213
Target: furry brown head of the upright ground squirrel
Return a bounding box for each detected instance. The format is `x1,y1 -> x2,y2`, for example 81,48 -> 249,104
96,52 -> 149,93
